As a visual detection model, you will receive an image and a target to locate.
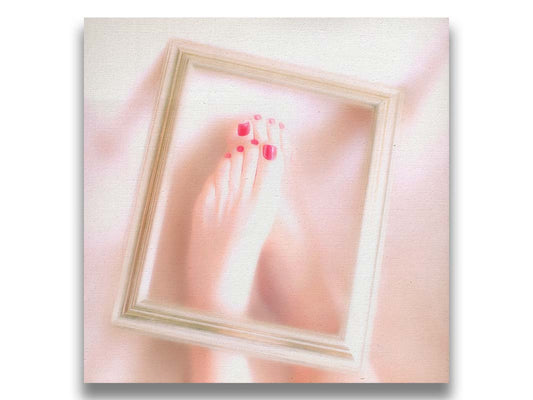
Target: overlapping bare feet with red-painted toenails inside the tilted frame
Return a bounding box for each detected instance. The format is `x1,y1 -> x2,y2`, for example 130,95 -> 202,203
187,115 -> 284,314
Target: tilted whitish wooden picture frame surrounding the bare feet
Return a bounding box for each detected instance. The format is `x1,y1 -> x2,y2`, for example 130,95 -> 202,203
113,40 -> 402,371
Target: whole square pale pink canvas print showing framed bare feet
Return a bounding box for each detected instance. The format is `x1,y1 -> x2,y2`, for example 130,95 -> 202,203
84,18 -> 449,383
